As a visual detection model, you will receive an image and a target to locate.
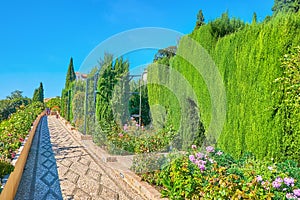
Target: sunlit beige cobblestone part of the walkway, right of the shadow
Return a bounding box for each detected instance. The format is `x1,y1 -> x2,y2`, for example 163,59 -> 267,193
48,116 -> 143,200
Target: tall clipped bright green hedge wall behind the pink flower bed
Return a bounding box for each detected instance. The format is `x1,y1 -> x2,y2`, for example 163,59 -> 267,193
148,13 -> 300,162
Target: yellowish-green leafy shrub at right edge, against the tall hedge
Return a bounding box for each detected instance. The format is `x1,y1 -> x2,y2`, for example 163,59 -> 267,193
273,47 -> 300,162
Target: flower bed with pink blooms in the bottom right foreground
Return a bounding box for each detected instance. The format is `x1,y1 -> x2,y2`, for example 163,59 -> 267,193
134,145 -> 300,199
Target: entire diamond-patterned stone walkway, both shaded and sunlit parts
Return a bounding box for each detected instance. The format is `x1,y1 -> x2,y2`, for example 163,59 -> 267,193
16,116 -> 144,200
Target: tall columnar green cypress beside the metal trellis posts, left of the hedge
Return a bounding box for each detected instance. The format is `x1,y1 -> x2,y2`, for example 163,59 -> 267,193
96,54 -> 129,145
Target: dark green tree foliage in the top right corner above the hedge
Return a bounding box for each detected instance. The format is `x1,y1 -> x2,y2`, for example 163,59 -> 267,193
272,0 -> 300,14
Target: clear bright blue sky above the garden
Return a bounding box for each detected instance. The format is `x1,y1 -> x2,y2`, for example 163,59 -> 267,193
0,0 -> 273,99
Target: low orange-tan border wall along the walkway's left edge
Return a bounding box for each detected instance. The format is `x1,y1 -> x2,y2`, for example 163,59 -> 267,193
0,111 -> 45,200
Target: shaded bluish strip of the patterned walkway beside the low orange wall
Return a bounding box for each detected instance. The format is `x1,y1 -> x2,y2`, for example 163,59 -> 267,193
15,117 -> 62,200
